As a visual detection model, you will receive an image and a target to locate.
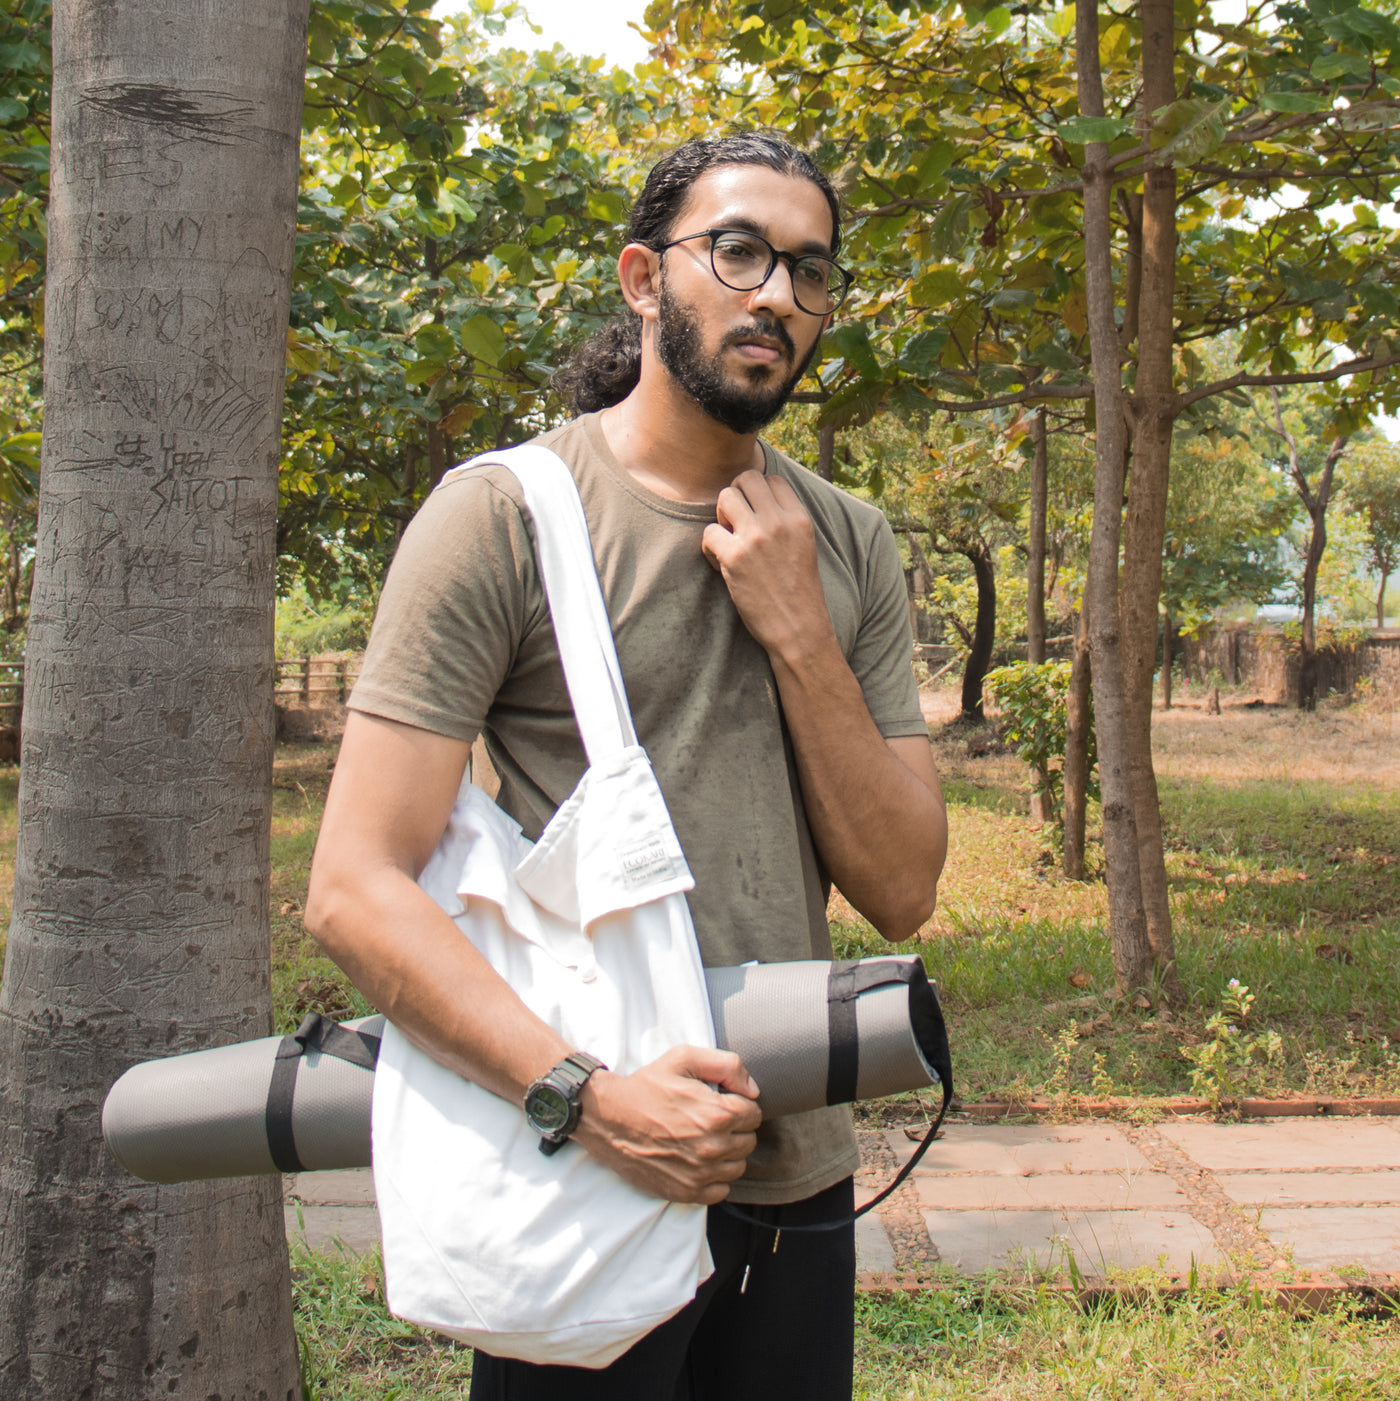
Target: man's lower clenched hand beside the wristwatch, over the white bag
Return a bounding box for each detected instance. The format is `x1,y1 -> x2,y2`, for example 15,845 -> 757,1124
573,1047 -> 762,1206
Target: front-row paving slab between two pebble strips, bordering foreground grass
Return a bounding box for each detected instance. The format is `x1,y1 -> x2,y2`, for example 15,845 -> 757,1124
924,1212 -> 1223,1276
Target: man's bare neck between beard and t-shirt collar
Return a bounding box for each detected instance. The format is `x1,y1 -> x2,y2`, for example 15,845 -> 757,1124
601,371 -> 764,502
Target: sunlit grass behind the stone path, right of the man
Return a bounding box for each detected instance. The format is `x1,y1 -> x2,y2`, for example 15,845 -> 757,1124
832,700 -> 1400,1101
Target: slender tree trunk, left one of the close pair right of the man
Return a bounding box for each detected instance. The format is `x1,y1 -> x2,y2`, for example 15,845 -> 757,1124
1075,4 -> 1152,995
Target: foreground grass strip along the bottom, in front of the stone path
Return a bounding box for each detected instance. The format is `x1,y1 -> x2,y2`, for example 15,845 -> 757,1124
293,1244 -> 1400,1401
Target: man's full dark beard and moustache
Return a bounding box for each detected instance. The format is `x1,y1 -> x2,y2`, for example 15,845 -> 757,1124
656,272 -> 821,433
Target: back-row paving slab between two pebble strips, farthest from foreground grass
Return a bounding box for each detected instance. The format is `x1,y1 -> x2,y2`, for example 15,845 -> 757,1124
886,1124 -> 1152,1177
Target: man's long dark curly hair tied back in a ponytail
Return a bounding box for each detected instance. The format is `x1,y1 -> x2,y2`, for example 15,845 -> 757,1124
552,132 -> 841,413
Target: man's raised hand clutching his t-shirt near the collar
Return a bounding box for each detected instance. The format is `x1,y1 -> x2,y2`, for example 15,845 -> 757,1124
701,471 -> 834,660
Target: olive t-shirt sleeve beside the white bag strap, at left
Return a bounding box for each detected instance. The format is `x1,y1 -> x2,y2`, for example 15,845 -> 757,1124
349,471 -> 542,743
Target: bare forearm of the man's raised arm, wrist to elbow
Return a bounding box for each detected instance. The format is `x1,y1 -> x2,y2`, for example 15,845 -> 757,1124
771,635 -> 947,940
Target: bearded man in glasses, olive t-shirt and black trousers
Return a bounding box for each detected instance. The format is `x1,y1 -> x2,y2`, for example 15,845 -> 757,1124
307,134 -> 946,1401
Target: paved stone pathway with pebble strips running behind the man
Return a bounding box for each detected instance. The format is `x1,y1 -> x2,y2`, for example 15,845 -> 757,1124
286,1118 -> 1400,1282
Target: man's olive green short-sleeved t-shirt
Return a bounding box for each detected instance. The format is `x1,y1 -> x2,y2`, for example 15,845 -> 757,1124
350,415 -> 928,1203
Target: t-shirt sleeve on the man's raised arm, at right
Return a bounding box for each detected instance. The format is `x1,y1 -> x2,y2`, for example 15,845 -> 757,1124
851,517 -> 928,740
